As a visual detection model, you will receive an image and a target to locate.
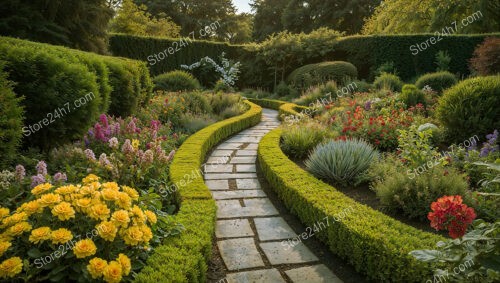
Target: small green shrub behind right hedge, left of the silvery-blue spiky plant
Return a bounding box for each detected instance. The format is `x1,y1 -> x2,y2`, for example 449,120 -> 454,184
281,122 -> 326,159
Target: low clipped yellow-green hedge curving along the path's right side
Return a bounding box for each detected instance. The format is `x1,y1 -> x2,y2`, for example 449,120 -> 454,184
258,129 -> 444,282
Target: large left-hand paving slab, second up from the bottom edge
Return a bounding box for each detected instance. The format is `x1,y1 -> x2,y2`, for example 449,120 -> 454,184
217,238 -> 264,270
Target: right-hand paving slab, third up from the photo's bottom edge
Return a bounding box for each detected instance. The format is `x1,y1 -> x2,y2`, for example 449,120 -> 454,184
253,217 -> 297,241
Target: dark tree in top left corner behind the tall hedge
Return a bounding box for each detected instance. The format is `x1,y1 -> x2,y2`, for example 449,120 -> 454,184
0,0 -> 113,53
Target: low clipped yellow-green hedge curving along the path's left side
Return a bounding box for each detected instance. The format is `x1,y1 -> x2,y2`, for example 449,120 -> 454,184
135,101 -> 262,283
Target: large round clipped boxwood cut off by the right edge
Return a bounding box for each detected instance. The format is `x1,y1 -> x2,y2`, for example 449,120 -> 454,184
436,75 -> 500,143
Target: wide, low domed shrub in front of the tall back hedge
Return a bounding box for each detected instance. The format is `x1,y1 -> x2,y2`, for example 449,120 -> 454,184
287,61 -> 358,89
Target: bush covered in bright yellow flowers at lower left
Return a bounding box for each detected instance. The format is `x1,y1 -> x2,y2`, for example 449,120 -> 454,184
0,174 -> 165,282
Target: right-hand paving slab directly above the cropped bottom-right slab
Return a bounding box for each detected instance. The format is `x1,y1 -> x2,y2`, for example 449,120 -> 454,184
259,241 -> 318,265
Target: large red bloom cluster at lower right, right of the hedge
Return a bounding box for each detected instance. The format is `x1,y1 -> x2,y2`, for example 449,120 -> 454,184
427,195 -> 476,239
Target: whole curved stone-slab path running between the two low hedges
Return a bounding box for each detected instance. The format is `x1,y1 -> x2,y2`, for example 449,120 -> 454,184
204,109 -> 342,283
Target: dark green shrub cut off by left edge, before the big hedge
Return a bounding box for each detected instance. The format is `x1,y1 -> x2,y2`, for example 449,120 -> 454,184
0,62 -> 24,169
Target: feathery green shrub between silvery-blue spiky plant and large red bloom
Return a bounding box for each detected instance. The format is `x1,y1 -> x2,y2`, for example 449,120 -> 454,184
369,157 -> 468,220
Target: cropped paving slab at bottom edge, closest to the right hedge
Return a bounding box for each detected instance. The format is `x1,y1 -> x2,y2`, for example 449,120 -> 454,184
285,264 -> 343,283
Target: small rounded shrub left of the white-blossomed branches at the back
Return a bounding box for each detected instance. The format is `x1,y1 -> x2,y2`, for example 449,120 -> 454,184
153,71 -> 200,91
